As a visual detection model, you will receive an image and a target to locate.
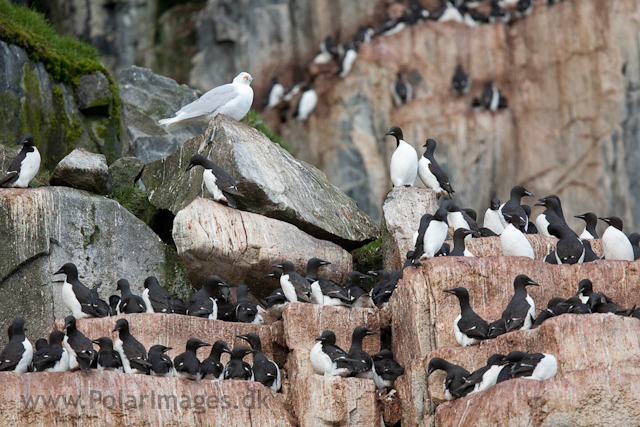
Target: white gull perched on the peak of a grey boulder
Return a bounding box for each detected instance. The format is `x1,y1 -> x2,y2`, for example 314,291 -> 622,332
158,72 -> 253,131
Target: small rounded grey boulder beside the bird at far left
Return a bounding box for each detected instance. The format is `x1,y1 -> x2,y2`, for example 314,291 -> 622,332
51,148 -> 109,194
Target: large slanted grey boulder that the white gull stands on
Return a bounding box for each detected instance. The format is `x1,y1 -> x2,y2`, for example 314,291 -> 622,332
142,116 -> 378,248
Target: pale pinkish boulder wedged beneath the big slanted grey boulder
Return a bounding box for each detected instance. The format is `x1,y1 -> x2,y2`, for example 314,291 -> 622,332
173,197 -> 352,297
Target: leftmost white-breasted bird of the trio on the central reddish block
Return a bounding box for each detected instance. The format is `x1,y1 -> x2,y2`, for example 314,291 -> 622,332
309,331 -> 355,377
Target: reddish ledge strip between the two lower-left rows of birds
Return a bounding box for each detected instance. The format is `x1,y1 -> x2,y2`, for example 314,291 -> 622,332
54,313 -> 286,366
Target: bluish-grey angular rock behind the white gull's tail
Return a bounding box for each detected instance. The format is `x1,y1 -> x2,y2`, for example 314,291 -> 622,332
119,67 -> 204,163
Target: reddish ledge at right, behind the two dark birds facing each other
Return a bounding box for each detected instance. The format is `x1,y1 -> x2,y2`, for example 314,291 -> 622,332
390,257 -> 640,363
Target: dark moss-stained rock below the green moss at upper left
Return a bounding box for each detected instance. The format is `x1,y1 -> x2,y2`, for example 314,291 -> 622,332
0,41 -> 121,170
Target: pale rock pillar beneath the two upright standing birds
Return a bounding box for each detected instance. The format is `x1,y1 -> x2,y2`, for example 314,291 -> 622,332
380,187 -> 440,271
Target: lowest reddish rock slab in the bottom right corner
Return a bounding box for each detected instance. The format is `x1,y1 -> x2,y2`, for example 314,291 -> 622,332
436,369 -> 640,427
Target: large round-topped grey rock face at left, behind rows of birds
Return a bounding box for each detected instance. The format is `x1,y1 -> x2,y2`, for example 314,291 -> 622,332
0,187 -> 188,346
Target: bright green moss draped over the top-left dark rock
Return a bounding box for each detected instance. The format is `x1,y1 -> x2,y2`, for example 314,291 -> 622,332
0,0 -> 120,132
